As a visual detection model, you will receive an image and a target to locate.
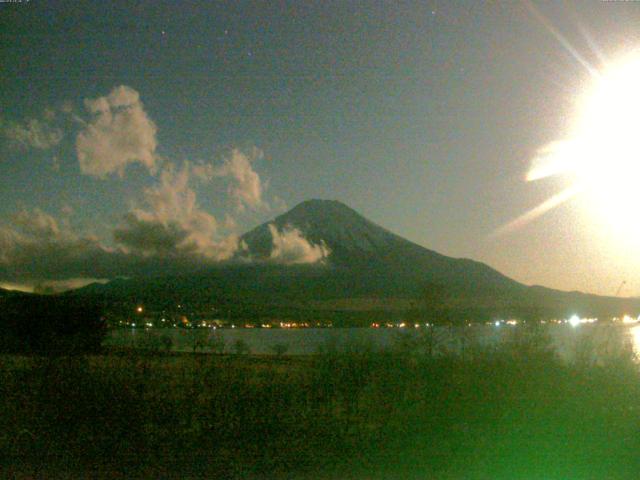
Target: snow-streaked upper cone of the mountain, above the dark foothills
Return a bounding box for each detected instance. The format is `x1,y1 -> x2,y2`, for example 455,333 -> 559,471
242,200 -> 524,290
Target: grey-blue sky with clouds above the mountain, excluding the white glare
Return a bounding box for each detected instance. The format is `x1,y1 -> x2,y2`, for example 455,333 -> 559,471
0,0 -> 640,295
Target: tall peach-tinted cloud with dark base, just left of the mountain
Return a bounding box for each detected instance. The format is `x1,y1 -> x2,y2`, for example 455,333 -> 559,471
114,163 -> 238,260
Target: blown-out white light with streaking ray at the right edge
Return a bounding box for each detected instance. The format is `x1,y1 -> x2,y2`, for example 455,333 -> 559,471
504,51 -> 640,238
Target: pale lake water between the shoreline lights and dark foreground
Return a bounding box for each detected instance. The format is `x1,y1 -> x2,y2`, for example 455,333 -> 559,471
104,323 -> 640,358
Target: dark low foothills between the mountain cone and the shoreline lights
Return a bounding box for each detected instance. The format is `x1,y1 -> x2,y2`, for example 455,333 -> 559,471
68,278 -> 640,327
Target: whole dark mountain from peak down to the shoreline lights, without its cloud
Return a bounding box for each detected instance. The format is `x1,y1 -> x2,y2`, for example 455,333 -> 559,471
75,200 -> 640,324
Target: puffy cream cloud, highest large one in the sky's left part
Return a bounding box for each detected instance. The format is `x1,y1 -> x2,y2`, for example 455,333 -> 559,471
76,85 -> 158,178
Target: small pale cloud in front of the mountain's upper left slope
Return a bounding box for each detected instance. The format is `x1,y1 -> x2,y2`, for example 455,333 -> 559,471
269,224 -> 331,265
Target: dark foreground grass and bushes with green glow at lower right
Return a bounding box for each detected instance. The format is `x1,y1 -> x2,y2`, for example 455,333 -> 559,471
0,329 -> 640,480
